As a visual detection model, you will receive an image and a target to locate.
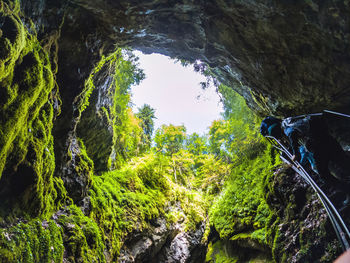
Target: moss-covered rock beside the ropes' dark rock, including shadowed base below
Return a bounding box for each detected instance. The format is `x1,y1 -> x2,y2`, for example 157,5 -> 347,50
206,142 -> 279,262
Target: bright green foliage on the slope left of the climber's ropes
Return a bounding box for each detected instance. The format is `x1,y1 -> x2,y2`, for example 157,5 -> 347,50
210,143 -> 275,243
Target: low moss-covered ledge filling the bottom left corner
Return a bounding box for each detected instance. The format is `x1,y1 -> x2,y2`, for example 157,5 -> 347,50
0,205 -> 106,263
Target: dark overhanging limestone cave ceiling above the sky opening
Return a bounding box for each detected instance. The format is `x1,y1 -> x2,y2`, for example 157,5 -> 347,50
23,0 -> 350,118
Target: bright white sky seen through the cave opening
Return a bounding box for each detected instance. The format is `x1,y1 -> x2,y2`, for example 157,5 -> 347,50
131,52 -> 222,135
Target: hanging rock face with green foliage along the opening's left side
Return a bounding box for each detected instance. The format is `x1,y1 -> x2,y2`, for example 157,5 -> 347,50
76,48 -> 144,171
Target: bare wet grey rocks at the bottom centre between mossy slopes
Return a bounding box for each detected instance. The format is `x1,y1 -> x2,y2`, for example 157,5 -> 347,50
118,218 -> 206,263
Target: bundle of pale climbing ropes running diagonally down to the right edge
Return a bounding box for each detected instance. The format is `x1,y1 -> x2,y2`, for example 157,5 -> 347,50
266,137 -> 350,251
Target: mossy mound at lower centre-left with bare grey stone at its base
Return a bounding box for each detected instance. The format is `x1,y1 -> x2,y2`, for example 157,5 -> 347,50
90,154 -> 205,262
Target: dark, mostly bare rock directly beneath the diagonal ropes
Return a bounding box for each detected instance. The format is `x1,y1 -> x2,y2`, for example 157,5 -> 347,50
266,166 -> 349,262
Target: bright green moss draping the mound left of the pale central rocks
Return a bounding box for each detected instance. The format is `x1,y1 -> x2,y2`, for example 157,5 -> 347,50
90,154 -> 169,255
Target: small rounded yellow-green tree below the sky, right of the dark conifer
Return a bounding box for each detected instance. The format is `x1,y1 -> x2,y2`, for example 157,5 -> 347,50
154,124 -> 186,156
